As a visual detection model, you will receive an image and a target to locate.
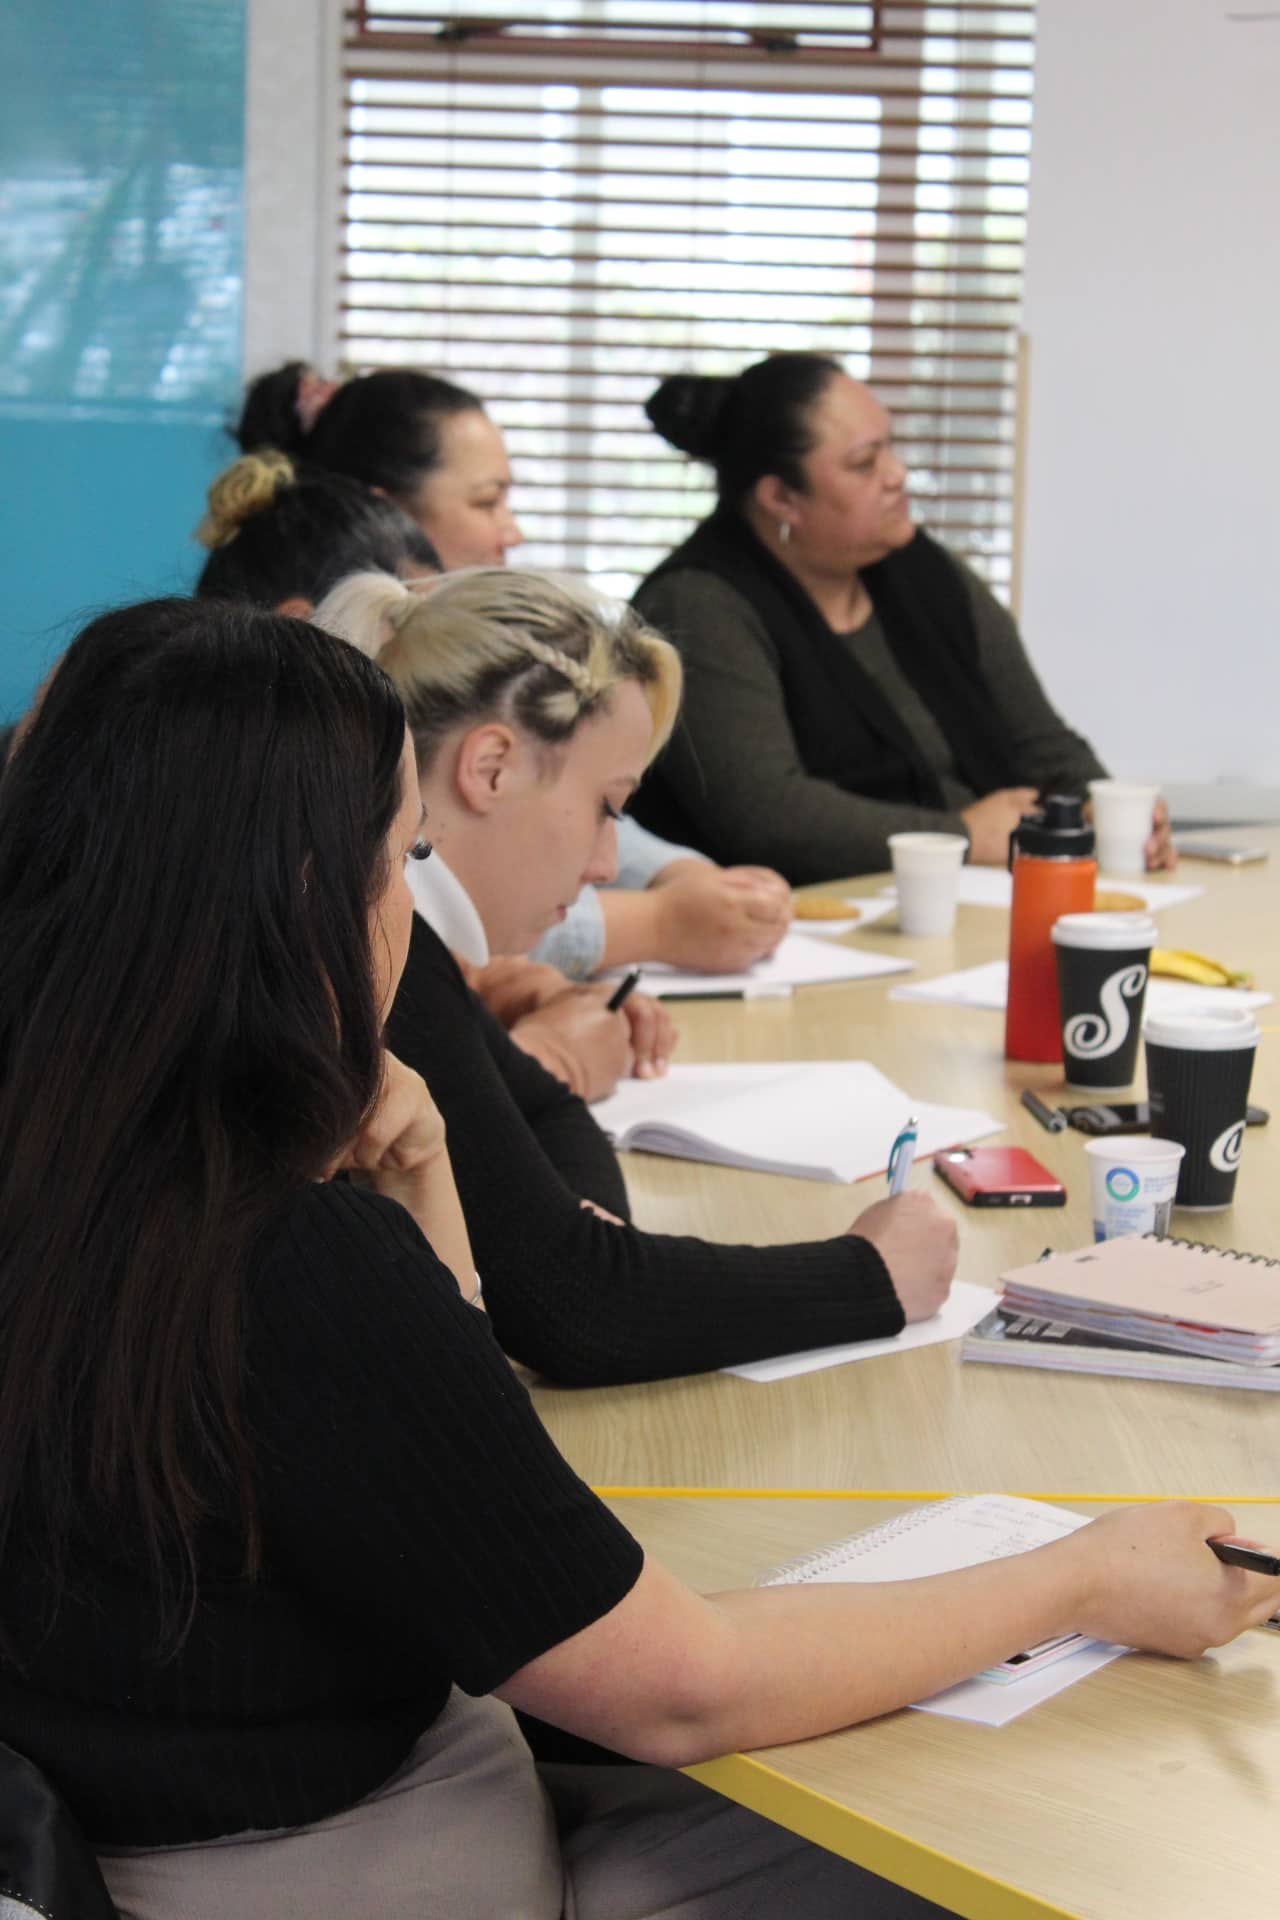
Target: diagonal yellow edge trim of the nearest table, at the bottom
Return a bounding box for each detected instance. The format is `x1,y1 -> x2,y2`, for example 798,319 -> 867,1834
683,1753 -> 1071,1920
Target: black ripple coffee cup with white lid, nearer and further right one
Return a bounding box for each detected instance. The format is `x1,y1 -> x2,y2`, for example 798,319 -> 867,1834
1146,1006 -> 1257,1213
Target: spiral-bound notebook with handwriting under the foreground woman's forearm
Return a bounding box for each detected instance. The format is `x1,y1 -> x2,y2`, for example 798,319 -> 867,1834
756,1494 -> 1123,1726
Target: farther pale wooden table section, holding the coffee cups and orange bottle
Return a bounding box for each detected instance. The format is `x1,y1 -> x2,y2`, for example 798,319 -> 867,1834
533,829 -> 1280,1498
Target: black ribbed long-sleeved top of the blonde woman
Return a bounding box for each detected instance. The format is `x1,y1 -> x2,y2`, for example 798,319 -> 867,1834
388,918 -> 904,1386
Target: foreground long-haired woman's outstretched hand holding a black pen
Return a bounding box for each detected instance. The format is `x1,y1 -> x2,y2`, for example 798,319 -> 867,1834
1038,1500 -> 1280,1661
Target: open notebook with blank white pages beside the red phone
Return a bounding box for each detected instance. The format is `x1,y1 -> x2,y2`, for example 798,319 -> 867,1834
591,1060 -> 1004,1181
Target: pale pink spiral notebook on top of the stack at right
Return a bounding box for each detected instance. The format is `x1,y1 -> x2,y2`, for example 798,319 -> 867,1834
1000,1235 -> 1280,1365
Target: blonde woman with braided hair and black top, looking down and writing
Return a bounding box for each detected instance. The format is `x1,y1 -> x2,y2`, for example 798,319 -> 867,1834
317,568 -> 956,1386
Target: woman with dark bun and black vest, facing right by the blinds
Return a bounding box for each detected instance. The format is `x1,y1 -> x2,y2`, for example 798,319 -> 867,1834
635,353 -> 1173,883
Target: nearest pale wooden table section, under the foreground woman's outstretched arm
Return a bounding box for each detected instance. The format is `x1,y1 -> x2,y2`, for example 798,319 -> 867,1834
610,1498 -> 1280,1920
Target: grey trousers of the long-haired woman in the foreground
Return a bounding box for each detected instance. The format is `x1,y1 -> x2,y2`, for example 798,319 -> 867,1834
100,1692 -> 940,1920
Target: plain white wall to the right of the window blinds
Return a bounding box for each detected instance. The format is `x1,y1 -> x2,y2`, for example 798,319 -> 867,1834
1021,0 -> 1280,816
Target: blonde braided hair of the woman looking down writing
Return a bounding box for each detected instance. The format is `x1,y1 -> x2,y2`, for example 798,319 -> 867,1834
313,566 -> 681,770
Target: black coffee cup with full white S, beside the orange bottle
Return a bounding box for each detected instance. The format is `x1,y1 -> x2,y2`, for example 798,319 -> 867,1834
1054,914 -> 1155,1092
